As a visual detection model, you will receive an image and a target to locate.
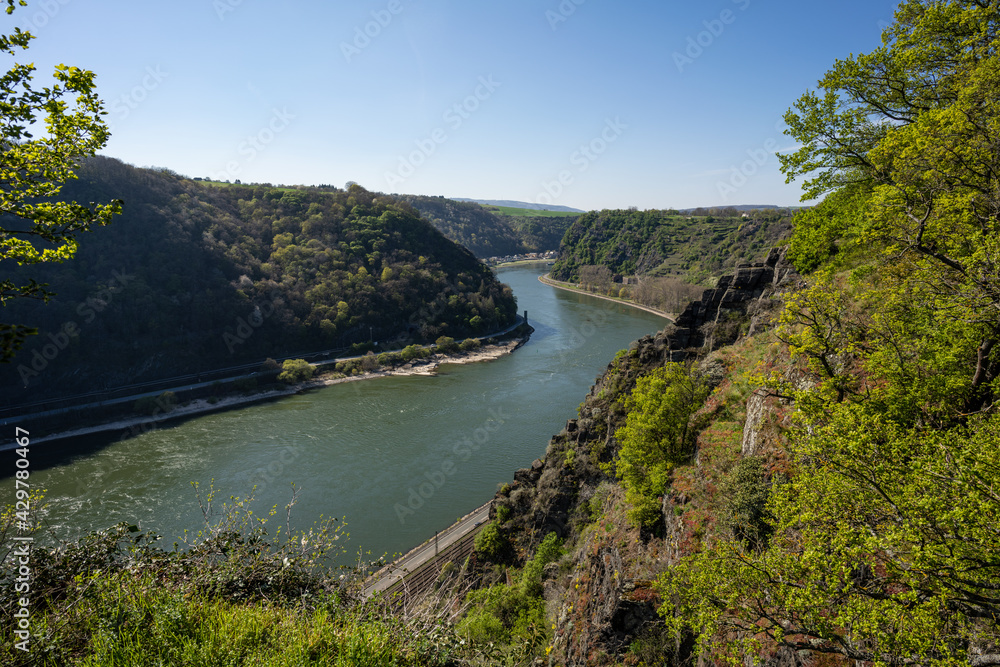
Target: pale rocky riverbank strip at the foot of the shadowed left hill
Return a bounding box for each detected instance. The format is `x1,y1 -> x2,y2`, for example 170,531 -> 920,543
7,340 -> 531,451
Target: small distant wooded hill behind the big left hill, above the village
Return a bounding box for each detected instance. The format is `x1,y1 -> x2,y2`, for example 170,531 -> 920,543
400,195 -> 574,258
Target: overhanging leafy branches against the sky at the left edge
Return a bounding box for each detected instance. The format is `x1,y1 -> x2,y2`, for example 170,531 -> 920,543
0,0 -> 121,362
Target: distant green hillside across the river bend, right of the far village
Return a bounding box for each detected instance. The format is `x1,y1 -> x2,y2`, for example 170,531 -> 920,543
552,209 -> 790,283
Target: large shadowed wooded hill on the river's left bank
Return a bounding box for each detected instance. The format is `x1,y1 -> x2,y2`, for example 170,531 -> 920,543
0,158 -> 516,401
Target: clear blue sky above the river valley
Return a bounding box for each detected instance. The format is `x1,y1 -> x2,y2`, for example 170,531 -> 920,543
7,0 -> 896,209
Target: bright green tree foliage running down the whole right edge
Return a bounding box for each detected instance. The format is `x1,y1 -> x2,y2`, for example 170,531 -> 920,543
660,0 -> 1000,665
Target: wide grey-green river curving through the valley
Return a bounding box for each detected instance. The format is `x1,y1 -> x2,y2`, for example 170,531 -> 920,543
11,265 -> 667,562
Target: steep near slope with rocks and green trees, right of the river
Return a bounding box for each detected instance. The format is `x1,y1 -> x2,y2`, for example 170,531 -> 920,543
465,0 -> 1000,667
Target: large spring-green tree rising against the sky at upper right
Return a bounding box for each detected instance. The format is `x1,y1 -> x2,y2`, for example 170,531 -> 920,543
779,0 -> 1000,411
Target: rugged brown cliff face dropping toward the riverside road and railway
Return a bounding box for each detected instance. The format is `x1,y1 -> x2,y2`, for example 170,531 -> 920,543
492,251 -> 799,665
